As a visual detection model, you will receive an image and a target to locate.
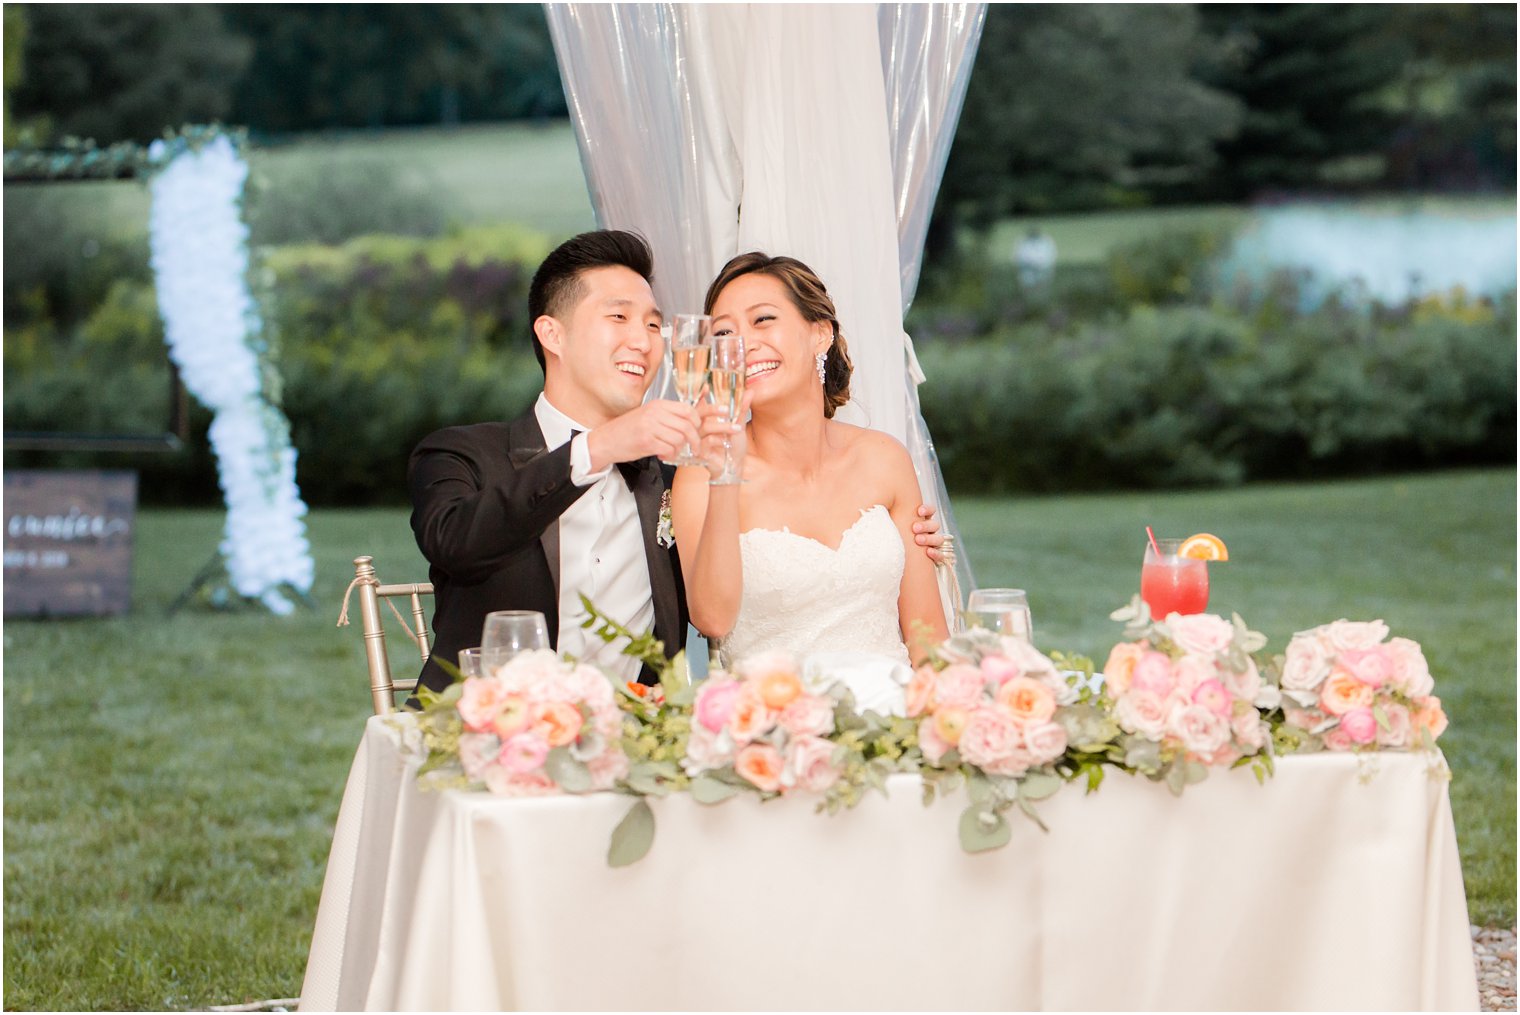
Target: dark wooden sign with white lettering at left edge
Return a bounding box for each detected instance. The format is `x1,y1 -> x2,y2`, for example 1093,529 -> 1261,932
5,470 -> 137,617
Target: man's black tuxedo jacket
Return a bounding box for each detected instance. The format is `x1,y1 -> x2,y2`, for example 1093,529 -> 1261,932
407,409 -> 687,705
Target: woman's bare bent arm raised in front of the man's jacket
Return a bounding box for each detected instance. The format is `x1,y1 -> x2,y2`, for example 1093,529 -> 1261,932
670,437 -> 747,638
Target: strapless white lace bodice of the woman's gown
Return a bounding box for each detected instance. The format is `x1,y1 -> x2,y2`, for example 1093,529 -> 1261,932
719,504 -> 907,664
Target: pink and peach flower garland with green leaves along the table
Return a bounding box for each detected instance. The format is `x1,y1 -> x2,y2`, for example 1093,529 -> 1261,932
416,597 -> 1446,866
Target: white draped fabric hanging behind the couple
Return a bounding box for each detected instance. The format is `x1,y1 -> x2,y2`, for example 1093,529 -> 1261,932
546,3 -> 983,617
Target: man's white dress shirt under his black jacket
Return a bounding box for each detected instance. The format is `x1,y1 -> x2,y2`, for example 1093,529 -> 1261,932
534,394 -> 655,681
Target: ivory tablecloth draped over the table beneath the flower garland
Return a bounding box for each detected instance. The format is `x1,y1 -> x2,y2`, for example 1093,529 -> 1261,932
301,717 -> 1477,1010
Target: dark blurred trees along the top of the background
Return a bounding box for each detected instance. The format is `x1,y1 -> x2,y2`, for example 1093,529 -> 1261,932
5,3 -> 1515,232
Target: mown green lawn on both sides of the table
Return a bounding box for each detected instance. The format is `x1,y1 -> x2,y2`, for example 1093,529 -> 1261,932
3,471 -> 1515,1009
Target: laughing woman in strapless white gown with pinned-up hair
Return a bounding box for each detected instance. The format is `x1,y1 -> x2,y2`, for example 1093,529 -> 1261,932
672,252 -> 947,707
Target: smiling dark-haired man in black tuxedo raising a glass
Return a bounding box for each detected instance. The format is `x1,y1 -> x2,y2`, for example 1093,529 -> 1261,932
407,229 -> 947,707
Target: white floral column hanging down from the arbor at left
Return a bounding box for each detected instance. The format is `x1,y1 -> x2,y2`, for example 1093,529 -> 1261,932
147,128 -> 313,615
